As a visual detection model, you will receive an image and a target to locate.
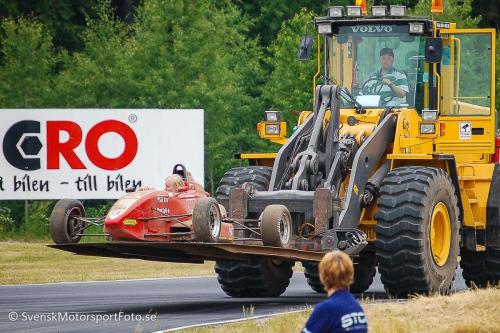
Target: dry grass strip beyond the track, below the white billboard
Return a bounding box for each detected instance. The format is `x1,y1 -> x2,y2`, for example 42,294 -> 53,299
0,241 -> 214,285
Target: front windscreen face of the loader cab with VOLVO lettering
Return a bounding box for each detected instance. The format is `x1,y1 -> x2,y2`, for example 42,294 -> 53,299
316,17 -> 433,109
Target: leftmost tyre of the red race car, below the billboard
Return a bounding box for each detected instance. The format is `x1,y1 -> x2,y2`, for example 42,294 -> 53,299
50,199 -> 85,244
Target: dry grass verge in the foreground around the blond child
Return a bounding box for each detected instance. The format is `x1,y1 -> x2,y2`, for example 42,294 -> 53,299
186,287 -> 500,333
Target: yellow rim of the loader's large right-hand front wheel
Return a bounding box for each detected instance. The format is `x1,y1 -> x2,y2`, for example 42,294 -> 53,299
430,202 -> 451,266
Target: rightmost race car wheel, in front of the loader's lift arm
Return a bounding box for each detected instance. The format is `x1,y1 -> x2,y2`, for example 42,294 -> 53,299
260,205 -> 292,248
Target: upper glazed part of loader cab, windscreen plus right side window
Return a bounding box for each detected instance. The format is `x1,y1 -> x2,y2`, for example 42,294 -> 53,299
315,10 -> 495,118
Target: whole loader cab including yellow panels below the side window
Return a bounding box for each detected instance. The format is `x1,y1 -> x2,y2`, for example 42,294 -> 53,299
315,11 -> 497,163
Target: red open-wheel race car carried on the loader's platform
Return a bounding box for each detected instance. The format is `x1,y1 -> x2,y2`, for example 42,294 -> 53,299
50,164 -> 233,244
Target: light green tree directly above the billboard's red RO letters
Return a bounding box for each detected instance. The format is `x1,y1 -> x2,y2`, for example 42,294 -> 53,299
53,1 -> 139,108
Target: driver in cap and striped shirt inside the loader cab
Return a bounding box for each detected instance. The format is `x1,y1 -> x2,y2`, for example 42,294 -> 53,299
364,47 -> 409,106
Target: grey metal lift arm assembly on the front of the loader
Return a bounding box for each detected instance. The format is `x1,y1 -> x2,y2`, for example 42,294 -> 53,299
229,85 -> 397,254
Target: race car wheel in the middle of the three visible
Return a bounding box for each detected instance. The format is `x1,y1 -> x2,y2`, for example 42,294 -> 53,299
193,198 -> 222,243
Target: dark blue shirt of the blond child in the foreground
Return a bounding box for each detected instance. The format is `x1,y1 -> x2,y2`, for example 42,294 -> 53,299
302,290 -> 368,333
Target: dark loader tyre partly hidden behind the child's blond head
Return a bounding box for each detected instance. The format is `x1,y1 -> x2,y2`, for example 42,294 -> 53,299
302,253 -> 376,293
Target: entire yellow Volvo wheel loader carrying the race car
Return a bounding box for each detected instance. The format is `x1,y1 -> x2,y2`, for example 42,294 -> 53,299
216,6 -> 500,297
